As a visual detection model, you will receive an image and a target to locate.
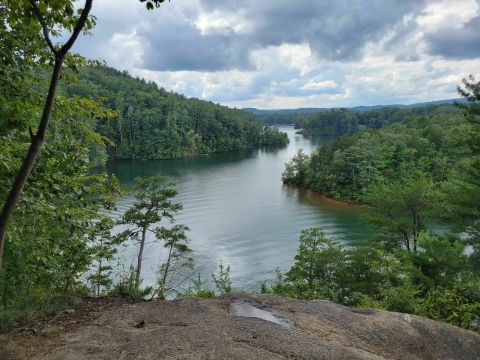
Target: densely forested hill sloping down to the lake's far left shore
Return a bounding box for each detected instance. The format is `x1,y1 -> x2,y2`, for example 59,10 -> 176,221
62,66 -> 288,159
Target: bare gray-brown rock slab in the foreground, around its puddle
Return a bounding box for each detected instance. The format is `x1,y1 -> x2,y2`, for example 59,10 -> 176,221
31,295 -> 480,360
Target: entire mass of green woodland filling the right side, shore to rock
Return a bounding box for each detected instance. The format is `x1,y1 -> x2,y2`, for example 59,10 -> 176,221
276,77 -> 480,328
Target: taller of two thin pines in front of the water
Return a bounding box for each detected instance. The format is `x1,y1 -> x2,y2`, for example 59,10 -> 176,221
119,175 -> 186,290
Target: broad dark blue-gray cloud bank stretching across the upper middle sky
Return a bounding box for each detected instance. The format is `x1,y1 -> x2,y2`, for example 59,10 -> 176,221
139,0 -> 425,71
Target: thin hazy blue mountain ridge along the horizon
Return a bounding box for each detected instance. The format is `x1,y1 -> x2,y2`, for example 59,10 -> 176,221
242,98 -> 465,115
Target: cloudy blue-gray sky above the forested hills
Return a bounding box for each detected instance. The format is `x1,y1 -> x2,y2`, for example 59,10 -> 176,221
69,0 -> 480,109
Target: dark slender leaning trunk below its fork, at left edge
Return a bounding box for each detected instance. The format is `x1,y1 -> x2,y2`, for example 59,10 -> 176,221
0,55 -> 63,267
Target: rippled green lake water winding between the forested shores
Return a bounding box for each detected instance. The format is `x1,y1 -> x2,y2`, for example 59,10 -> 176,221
107,127 -> 373,291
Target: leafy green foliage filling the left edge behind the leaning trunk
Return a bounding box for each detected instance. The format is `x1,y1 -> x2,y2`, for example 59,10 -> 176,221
0,0 -> 194,330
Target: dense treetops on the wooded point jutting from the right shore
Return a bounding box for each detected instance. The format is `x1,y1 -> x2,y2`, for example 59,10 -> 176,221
285,115 -> 471,202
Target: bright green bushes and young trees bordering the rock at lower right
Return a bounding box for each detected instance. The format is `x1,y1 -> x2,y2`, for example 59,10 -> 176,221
262,228 -> 480,328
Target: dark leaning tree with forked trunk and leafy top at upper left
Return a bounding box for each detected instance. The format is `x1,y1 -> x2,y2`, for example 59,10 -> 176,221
0,0 -> 172,267
